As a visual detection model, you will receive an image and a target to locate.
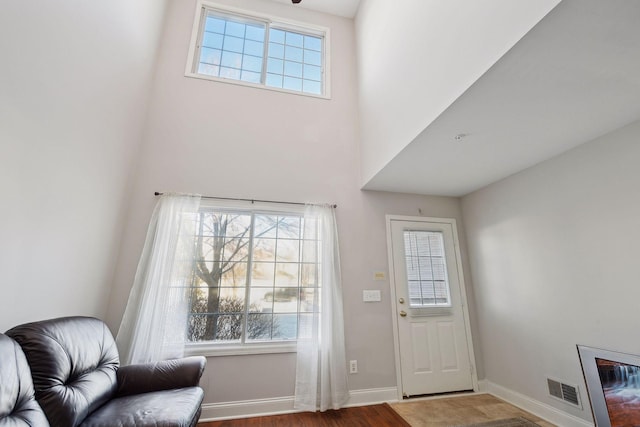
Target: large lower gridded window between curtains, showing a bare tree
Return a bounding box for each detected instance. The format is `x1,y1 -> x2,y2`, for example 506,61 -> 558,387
188,202 -> 321,346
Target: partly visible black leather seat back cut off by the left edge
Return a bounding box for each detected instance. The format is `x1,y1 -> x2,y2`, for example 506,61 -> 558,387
0,334 -> 49,427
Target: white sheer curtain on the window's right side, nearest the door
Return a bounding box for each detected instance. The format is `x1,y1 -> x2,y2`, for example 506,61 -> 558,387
294,205 -> 349,411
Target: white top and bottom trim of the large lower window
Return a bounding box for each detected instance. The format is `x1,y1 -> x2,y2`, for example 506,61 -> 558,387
185,199 -> 316,357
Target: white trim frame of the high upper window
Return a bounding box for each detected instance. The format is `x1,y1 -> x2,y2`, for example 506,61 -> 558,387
184,0 -> 331,99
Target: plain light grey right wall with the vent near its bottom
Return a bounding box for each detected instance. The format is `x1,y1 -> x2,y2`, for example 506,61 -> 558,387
462,118 -> 640,420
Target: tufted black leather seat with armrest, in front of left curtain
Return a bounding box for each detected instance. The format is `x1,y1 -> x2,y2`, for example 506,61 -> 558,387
6,317 -> 205,427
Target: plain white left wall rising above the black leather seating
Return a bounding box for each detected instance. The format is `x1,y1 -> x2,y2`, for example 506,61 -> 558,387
0,0 -> 164,331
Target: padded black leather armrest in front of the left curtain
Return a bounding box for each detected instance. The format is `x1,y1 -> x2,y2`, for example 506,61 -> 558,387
116,356 -> 207,396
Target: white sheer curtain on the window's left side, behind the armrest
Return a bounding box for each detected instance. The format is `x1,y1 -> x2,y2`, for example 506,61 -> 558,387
116,194 -> 200,364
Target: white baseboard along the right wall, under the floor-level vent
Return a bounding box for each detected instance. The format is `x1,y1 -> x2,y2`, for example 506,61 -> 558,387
478,380 -> 593,427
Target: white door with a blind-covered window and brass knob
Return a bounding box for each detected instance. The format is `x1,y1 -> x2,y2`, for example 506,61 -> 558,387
387,216 -> 477,397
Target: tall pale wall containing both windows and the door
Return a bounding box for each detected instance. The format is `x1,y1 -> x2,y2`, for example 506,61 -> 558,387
108,0 -> 476,403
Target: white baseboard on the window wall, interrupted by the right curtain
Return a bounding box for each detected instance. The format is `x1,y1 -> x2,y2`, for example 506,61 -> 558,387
200,387 -> 398,421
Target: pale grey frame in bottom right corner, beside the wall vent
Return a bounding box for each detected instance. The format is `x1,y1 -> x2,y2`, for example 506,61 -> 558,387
577,345 -> 640,427
